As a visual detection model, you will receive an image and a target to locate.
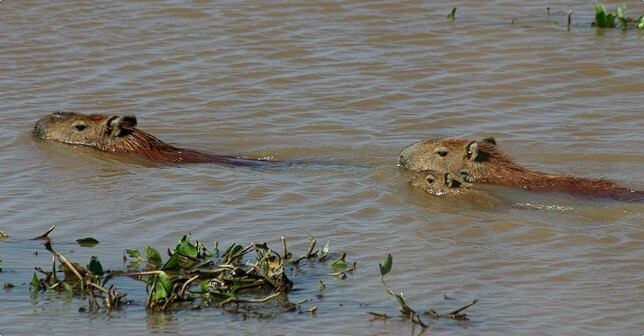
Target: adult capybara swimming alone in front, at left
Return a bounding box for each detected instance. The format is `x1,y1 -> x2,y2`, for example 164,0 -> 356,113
33,112 -> 264,166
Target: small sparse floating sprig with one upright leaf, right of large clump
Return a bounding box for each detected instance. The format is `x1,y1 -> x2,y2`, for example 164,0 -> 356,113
367,254 -> 478,328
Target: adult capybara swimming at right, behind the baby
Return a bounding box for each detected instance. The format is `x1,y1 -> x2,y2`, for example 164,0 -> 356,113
398,138 -> 644,202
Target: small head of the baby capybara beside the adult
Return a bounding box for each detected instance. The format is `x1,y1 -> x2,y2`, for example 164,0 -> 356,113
409,170 -> 471,196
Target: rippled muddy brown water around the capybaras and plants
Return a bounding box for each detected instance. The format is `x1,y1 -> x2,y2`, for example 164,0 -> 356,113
0,0 -> 644,335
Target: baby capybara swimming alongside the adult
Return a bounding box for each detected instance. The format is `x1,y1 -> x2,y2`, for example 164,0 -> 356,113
409,170 -> 503,206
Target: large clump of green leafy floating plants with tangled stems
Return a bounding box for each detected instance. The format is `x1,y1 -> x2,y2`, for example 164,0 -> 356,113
30,227 -> 356,316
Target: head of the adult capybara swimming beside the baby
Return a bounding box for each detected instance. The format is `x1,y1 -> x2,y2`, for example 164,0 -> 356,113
398,137 -> 515,176
